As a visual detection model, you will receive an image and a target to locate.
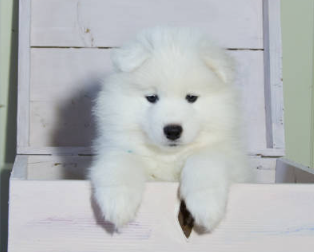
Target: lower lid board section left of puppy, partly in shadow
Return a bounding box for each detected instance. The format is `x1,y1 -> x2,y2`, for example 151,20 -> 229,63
30,49 -> 112,149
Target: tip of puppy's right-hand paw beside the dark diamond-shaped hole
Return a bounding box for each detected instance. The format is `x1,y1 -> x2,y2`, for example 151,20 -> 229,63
184,190 -> 227,232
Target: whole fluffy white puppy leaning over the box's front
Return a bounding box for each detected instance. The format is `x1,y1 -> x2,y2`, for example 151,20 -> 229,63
90,27 -> 250,231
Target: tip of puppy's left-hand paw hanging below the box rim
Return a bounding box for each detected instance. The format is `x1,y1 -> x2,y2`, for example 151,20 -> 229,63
95,186 -> 142,229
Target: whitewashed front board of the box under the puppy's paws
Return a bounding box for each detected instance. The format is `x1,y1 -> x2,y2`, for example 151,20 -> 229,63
9,181 -> 314,252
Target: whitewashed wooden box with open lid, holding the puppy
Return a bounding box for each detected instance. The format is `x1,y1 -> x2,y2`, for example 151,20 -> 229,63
9,0 -> 314,252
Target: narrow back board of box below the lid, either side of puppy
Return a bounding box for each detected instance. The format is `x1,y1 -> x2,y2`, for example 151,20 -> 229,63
27,155 -> 276,183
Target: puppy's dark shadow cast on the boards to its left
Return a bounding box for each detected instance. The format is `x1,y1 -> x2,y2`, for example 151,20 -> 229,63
49,75 -> 103,180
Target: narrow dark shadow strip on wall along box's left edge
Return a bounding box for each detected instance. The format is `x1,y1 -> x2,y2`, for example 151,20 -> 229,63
0,0 -> 19,251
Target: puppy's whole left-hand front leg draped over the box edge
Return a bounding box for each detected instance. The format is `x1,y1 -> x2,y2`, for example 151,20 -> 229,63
90,153 -> 145,229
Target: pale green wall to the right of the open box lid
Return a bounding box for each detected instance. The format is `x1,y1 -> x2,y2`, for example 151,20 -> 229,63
281,0 -> 314,167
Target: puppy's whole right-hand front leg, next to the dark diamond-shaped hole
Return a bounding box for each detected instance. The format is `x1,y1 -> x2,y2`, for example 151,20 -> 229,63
180,152 -> 232,231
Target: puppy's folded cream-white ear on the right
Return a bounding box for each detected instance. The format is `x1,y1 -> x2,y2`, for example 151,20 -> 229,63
200,40 -> 235,84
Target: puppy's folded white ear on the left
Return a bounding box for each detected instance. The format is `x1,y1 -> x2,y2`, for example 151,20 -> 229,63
111,41 -> 150,72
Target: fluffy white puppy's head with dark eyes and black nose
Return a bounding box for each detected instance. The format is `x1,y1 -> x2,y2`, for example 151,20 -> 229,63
108,28 -> 238,148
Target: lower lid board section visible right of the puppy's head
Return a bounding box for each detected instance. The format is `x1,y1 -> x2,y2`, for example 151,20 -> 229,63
234,51 -> 267,152
